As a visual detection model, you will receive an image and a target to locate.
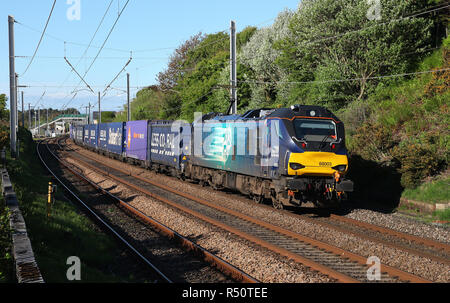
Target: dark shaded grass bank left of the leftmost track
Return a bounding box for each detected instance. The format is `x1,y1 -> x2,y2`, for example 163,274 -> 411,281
3,129 -> 142,282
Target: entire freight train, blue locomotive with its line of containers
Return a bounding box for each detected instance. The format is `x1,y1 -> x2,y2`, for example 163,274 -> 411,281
70,105 -> 353,209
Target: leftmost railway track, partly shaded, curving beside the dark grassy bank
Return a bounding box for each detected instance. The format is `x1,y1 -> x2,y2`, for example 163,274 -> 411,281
38,139 -> 253,283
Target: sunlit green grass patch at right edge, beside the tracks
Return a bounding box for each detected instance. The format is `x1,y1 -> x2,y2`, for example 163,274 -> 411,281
403,177 -> 450,203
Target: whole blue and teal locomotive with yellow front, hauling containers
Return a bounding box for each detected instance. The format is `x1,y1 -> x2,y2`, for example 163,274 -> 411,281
182,105 -> 353,209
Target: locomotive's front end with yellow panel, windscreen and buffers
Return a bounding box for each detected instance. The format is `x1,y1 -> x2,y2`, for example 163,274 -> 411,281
274,105 -> 353,207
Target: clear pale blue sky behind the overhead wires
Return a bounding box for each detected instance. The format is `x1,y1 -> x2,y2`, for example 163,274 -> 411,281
0,0 -> 299,110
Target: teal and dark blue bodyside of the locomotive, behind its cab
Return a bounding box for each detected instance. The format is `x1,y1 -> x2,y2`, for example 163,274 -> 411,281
191,121 -> 279,178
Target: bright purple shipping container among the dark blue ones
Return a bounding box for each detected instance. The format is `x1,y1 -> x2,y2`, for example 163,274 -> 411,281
125,120 -> 148,161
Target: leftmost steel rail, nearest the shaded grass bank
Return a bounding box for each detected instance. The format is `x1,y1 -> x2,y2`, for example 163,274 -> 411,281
36,141 -> 173,283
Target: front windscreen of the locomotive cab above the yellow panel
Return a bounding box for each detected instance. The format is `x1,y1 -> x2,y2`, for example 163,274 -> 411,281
294,119 -> 337,142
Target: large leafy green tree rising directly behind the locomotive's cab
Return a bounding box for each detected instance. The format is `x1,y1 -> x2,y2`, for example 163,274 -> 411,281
276,0 -> 433,109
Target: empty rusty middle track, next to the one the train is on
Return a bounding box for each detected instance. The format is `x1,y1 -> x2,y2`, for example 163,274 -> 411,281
58,138 -> 429,282
